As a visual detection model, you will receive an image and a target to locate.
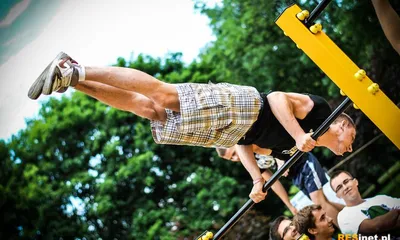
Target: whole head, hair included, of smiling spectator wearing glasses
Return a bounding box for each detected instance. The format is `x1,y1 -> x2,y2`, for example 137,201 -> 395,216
330,171 -> 361,202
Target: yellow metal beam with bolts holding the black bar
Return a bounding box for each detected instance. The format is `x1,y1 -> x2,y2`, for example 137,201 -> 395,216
276,5 -> 400,149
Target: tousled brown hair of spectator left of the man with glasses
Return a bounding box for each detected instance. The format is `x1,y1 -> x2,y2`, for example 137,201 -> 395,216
293,204 -> 322,237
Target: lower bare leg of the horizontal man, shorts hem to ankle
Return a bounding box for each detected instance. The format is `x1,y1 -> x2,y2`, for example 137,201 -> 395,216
75,80 -> 166,122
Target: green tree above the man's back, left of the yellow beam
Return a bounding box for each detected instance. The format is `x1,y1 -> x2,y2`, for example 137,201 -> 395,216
196,0 -> 340,95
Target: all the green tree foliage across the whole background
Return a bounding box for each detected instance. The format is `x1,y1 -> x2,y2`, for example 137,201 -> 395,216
0,0 -> 400,240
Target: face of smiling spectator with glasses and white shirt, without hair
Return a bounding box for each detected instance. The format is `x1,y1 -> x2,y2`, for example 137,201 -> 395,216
331,173 -> 359,201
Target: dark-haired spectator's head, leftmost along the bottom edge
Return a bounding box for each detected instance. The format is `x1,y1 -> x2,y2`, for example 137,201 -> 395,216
269,216 -> 300,240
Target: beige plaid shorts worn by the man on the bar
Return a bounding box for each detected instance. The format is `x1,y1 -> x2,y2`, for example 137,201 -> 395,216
151,83 -> 262,147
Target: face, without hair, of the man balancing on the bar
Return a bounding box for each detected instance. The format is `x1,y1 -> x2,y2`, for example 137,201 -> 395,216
330,121 -> 356,156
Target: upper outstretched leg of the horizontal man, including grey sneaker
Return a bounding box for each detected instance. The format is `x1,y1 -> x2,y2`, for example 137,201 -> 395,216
28,52 -> 179,112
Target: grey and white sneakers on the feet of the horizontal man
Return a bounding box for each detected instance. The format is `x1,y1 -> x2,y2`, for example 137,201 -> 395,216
28,52 -> 79,99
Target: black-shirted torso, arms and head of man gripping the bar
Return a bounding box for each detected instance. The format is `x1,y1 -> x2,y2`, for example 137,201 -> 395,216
236,92 -> 356,203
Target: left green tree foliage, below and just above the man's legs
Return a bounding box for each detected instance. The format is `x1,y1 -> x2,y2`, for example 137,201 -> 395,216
0,53 -> 260,239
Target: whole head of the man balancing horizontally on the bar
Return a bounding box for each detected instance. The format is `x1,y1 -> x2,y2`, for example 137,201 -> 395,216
327,113 -> 356,156
